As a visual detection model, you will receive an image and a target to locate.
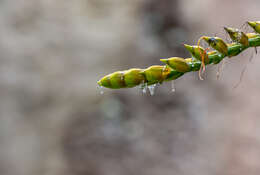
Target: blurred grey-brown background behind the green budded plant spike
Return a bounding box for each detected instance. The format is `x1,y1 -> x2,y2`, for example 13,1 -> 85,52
0,0 -> 260,175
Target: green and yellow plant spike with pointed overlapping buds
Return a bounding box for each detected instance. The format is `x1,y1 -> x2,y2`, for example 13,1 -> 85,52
97,21 -> 260,89
